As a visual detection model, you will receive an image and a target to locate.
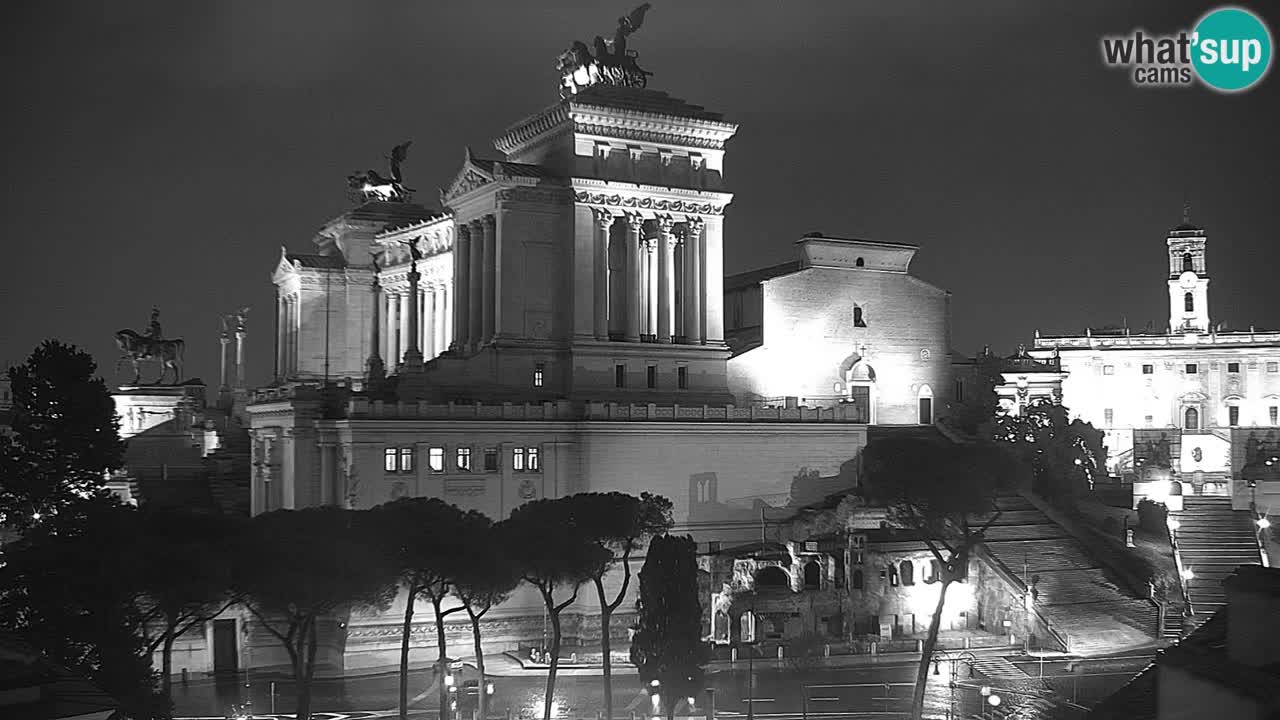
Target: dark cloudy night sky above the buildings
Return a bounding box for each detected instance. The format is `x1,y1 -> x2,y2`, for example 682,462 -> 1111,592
0,0 -> 1280,388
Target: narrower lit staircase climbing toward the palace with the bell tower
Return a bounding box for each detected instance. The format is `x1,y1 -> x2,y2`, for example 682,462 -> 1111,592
1170,495 -> 1262,618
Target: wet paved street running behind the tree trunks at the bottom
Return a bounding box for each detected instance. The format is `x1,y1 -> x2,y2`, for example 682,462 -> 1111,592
174,656 -> 1151,720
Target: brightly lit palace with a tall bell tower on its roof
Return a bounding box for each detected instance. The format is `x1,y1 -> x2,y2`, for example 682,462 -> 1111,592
1032,215 -> 1280,510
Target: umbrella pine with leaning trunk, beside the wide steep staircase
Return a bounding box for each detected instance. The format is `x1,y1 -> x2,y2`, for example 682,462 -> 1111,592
863,437 -> 1027,719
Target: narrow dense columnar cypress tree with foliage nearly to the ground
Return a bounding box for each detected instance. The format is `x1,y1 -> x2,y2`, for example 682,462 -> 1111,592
631,536 -> 710,720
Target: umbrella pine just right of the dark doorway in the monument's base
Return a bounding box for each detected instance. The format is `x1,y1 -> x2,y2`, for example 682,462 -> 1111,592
236,507 -> 397,720
